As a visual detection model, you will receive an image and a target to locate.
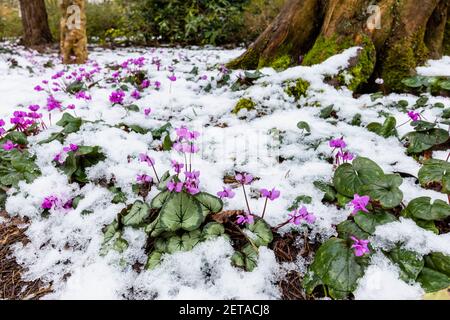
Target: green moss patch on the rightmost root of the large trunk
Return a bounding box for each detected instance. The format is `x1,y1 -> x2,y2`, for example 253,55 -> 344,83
382,31 -> 428,91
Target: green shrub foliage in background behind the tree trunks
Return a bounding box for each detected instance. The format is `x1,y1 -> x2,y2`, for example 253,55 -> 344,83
0,0 -> 285,45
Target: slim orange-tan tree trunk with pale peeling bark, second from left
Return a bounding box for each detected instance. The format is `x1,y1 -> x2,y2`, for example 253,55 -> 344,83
60,0 -> 88,64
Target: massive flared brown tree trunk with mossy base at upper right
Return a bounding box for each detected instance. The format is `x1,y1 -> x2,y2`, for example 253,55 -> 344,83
229,0 -> 450,90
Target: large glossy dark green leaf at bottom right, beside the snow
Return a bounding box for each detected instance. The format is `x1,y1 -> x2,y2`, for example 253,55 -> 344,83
307,238 -> 364,294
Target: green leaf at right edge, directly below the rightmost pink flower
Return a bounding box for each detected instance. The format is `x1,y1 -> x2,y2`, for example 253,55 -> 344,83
402,129 -> 449,154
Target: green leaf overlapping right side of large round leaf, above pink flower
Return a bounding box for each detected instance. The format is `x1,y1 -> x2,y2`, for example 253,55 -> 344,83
359,175 -> 403,208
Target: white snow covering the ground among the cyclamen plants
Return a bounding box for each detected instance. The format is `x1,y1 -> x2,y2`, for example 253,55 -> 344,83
0,43 -> 450,299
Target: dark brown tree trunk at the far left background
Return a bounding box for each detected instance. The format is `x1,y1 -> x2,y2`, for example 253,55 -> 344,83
20,0 -> 52,47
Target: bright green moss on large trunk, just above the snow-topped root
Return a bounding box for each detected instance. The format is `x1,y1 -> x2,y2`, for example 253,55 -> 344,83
303,36 -> 355,66
